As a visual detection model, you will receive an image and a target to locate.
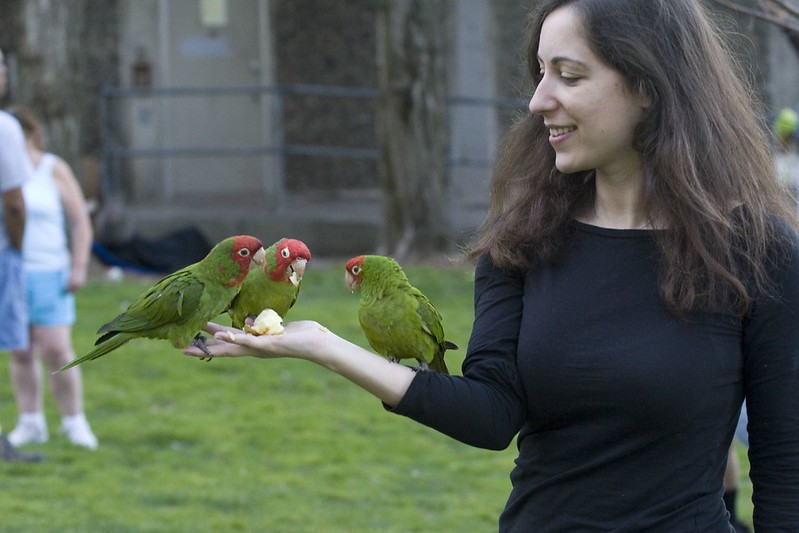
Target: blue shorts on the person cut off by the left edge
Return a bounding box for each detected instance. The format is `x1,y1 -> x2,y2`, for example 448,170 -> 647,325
0,248 -> 30,350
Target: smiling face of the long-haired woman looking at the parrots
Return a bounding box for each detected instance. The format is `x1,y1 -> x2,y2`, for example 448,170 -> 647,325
529,6 -> 645,179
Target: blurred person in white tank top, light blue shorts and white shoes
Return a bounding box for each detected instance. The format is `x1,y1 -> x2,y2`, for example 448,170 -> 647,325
8,106 -> 97,450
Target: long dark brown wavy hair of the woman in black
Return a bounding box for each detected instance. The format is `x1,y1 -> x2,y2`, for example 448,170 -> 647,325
468,0 -> 796,314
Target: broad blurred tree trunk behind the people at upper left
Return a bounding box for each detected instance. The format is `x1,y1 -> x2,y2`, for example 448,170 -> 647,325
0,0 -> 119,197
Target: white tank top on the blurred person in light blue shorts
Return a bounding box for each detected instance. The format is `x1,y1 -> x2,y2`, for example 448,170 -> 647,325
22,154 -> 71,271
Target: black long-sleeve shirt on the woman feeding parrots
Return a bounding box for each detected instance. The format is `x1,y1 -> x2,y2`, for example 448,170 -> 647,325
394,223 -> 799,533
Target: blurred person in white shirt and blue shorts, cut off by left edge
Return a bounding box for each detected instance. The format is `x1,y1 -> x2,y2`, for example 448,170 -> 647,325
0,46 -> 41,462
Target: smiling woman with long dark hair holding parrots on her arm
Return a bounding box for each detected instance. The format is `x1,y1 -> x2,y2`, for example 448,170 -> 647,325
186,0 -> 799,532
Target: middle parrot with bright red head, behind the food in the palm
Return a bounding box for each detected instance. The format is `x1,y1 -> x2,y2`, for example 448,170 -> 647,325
228,239 -> 311,329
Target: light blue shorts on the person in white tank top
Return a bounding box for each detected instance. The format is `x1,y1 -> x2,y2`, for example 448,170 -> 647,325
25,270 -> 75,326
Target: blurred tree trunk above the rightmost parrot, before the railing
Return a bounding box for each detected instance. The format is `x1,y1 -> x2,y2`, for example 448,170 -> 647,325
377,0 -> 450,261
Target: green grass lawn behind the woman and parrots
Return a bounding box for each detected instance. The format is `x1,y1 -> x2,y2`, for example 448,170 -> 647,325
0,264 -> 751,532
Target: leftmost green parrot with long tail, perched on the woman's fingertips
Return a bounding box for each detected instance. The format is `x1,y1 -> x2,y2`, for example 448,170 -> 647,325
57,235 -> 265,372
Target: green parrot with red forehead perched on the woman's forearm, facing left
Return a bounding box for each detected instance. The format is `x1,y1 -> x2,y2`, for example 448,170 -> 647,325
345,255 -> 458,374
